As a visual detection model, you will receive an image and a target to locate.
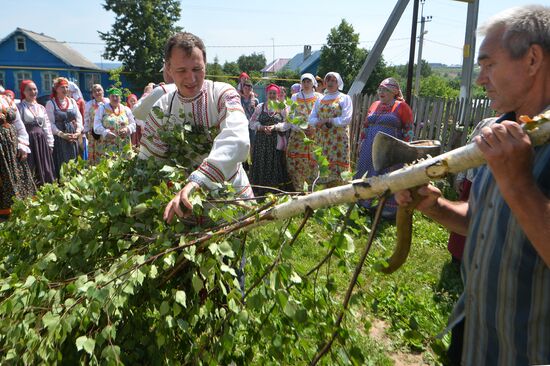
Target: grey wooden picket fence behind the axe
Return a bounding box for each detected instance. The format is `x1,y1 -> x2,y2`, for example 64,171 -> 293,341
350,95 -> 494,163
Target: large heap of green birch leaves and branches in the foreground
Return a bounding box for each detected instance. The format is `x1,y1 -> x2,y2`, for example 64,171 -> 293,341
0,128 -> 376,364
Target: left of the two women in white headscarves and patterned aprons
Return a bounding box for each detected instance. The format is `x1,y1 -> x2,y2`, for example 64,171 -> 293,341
286,73 -> 323,191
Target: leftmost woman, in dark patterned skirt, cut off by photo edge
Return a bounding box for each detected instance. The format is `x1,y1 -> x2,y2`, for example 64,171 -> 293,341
0,95 -> 36,220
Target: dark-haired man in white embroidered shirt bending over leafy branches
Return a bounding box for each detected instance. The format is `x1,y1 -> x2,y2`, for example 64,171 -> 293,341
139,32 -> 252,222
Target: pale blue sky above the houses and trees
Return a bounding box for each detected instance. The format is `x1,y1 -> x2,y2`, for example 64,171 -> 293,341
0,0 -> 550,65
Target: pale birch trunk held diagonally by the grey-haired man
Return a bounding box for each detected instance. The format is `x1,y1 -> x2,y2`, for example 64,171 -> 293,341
254,119 -> 550,229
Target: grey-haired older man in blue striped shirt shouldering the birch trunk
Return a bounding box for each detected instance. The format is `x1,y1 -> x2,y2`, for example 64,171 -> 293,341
396,6 -> 550,365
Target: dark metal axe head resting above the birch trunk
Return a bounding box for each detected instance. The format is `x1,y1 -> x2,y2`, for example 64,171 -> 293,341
372,132 -> 441,171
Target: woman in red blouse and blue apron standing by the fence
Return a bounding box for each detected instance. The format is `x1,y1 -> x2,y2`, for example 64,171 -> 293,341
355,78 -> 413,219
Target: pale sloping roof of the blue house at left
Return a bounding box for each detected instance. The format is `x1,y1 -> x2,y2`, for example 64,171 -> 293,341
0,28 -> 101,70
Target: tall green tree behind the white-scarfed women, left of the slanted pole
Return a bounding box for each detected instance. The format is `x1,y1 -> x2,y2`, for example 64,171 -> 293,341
318,19 -> 367,90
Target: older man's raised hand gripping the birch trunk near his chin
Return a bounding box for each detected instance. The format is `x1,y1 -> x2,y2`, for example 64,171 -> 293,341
475,121 -> 533,189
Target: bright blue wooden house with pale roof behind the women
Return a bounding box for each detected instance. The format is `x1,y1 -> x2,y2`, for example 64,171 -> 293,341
0,28 -> 123,100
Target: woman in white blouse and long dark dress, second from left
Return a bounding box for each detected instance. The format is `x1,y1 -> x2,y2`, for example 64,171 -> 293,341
17,80 -> 55,187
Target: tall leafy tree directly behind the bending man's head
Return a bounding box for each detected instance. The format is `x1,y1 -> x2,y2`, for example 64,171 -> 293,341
98,0 -> 181,87
